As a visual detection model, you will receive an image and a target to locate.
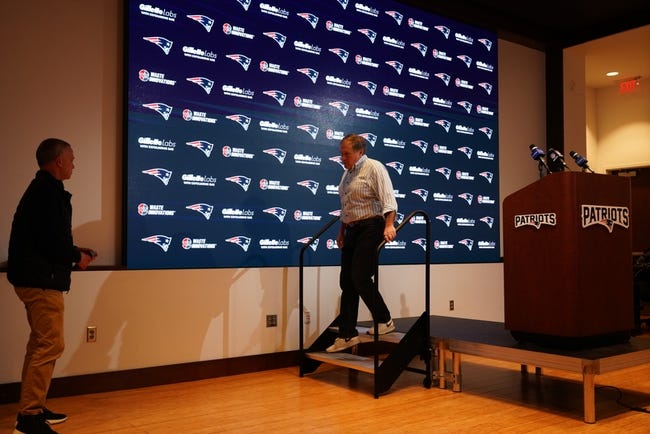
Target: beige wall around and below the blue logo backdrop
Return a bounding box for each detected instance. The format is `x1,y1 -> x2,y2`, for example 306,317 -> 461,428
0,0 -> 545,384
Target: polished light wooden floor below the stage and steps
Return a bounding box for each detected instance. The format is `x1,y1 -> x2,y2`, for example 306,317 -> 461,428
0,333 -> 650,434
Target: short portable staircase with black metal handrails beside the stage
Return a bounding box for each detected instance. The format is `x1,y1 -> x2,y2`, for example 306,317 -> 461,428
299,211 -> 433,398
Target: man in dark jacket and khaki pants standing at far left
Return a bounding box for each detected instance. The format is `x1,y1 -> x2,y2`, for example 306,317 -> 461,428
7,138 -> 96,434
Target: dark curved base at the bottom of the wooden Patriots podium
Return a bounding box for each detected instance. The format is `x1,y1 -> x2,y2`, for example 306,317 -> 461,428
510,330 -> 632,350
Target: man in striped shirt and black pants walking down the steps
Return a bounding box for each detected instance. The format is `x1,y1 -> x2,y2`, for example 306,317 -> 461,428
326,134 -> 397,353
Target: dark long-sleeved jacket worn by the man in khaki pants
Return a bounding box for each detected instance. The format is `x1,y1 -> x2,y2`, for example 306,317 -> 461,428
7,170 -> 81,291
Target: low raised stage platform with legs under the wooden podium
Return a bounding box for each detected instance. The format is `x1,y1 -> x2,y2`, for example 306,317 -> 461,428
418,316 -> 650,423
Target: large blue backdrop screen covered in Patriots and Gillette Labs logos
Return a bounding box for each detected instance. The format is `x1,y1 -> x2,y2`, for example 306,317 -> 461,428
125,0 -> 500,269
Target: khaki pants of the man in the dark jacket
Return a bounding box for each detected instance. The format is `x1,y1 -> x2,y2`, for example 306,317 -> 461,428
14,287 -> 64,415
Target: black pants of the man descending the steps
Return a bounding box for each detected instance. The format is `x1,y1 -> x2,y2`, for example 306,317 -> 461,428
338,218 -> 390,338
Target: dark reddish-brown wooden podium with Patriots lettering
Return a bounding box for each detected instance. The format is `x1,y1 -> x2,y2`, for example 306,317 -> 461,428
503,172 -> 634,348
